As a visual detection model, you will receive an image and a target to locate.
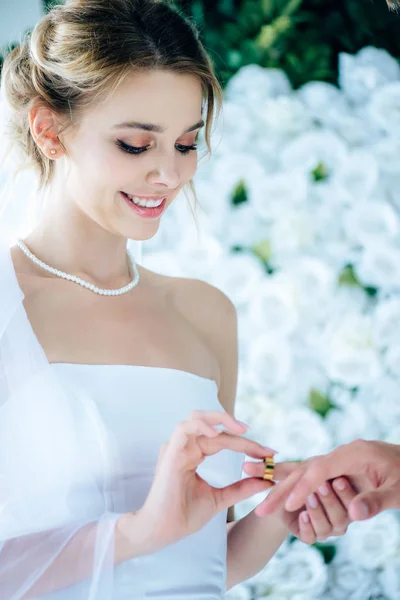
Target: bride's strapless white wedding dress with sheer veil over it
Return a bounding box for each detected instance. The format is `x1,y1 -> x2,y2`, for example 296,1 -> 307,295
0,241 -> 245,600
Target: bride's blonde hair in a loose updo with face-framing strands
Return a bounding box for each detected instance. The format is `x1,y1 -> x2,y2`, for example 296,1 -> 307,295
1,0 -> 222,213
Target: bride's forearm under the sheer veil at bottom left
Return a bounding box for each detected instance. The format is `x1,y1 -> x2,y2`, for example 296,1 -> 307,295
0,511 -> 157,600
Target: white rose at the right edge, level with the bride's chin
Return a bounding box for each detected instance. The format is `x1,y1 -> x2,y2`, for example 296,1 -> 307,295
343,200 -> 400,246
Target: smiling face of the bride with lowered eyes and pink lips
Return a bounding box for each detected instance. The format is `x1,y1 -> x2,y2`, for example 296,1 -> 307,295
50,70 -> 204,240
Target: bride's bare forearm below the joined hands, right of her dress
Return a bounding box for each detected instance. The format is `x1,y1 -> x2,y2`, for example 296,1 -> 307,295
226,511 -> 289,590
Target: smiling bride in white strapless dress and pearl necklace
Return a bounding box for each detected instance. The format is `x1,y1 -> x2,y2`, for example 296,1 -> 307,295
0,0 -> 354,600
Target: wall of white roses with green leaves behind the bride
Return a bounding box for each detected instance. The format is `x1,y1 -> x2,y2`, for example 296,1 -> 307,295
143,47 -> 400,600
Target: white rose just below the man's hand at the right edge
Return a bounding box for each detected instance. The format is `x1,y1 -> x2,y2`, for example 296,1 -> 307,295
339,511 -> 400,569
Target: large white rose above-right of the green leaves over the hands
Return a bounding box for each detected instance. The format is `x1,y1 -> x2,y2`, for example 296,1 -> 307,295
322,315 -> 381,387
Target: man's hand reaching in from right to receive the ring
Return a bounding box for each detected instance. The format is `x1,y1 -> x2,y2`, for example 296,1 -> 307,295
256,440 -> 400,521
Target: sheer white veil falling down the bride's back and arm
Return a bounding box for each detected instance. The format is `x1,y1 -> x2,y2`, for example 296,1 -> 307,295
0,81 -> 145,600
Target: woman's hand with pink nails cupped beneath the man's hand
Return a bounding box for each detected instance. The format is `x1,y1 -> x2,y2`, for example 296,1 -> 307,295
243,462 -> 357,544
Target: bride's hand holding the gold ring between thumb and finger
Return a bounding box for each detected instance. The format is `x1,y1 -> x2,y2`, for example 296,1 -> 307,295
138,411 -> 273,551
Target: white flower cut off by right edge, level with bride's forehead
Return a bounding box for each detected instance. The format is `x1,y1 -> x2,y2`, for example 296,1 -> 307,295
366,81 -> 400,135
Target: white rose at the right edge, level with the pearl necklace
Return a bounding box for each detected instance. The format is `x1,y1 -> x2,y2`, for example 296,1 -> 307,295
354,242 -> 400,289
